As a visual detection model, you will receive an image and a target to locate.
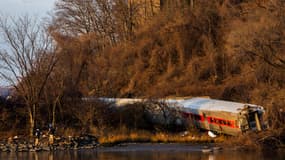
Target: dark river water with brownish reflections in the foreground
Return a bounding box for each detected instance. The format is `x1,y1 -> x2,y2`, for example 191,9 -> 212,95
0,144 -> 285,160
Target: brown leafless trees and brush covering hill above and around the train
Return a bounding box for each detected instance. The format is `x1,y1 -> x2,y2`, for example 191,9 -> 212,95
0,0 -> 285,146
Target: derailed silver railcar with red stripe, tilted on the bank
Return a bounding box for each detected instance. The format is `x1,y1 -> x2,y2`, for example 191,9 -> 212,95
166,98 -> 266,136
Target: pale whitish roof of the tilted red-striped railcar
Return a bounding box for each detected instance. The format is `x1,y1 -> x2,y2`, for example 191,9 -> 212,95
167,98 -> 263,113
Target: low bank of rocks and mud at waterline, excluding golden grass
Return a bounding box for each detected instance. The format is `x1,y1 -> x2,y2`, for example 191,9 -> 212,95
0,135 -> 221,152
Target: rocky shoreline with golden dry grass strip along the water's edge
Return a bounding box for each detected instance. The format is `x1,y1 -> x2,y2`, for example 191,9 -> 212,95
0,133 -> 285,153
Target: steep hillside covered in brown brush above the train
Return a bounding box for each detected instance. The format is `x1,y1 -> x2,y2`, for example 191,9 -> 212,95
88,2 -> 285,102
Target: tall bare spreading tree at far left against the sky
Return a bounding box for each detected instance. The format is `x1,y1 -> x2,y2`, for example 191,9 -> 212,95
0,16 -> 56,135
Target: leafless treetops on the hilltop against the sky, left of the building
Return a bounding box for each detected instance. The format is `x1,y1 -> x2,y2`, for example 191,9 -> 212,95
52,0 -> 142,45
